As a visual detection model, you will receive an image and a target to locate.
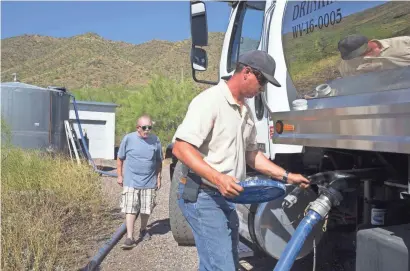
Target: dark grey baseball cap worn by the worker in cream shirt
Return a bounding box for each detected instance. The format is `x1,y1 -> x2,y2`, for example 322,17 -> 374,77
238,50 -> 281,87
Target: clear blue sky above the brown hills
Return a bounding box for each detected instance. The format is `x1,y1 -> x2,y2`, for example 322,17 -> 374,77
1,1 -> 234,44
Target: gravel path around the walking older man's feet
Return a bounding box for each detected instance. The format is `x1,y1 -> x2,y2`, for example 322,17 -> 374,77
96,165 -> 198,271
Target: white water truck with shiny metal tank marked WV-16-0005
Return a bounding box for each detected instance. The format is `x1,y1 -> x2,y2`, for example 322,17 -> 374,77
166,0 -> 410,271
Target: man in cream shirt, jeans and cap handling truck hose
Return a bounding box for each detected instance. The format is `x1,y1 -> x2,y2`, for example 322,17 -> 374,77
173,51 -> 309,271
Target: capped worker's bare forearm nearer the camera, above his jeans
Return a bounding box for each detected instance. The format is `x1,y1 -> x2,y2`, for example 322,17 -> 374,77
172,140 -> 221,185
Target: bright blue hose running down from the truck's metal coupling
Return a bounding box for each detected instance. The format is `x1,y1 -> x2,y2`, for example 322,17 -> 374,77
273,210 -> 322,271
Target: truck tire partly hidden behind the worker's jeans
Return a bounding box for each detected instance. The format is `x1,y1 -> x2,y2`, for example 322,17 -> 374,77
169,162 -> 195,246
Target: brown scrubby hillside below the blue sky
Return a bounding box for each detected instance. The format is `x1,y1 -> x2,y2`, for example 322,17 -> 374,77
1,33 -> 223,89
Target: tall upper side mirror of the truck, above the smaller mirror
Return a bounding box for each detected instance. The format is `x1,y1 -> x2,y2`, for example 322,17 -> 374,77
190,1 -> 208,46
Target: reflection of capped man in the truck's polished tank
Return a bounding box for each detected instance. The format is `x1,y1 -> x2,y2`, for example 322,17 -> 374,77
338,35 -> 410,77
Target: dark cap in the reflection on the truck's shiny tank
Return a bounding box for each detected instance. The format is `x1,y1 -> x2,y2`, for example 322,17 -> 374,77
337,35 -> 369,60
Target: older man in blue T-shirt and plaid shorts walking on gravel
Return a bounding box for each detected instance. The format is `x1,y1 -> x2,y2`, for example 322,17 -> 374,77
117,115 -> 163,249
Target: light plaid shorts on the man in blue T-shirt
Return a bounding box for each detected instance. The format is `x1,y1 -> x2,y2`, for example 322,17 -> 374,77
120,186 -> 156,215
